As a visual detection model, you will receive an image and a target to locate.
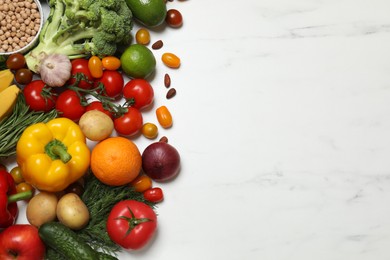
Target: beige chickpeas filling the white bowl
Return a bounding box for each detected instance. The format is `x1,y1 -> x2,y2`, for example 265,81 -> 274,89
0,0 -> 41,53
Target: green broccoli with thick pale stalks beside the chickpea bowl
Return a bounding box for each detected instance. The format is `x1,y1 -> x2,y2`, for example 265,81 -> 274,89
25,0 -> 133,73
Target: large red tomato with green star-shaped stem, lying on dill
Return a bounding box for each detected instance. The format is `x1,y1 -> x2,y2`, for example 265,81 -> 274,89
107,200 -> 157,250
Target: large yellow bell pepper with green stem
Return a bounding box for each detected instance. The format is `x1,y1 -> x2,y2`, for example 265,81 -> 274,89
16,118 -> 91,192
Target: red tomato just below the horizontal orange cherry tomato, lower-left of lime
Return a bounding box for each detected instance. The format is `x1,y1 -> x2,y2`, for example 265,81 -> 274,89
95,70 -> 125,98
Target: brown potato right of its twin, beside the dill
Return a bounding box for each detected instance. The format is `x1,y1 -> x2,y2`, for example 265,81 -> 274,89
57,193 -> 89,230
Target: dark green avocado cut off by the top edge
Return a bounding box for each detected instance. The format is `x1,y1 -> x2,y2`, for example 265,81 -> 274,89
126,0 -> 167,27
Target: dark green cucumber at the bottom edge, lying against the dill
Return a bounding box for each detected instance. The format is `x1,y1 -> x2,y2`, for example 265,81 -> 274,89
38,222 -> 117,260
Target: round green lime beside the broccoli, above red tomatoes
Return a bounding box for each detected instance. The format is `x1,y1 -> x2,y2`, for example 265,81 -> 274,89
121,44 -> 156,79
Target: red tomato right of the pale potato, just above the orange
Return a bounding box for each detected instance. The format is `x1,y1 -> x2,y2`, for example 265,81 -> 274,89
114,107 -> 143,136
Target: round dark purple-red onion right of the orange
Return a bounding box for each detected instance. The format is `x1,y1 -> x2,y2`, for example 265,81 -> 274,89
142,142 -> 180,182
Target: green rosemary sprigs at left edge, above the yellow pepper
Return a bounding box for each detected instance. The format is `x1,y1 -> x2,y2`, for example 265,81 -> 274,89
0,94 -> 58,158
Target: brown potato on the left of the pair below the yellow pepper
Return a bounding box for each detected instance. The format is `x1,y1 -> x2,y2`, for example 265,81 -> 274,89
26,191 -> 58,227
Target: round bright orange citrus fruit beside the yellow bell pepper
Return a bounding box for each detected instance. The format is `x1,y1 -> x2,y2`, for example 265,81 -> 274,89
91,136 -> 142,186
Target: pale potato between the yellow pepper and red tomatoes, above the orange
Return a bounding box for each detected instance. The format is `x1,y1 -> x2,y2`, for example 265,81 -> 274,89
79,110 -> 114,141
